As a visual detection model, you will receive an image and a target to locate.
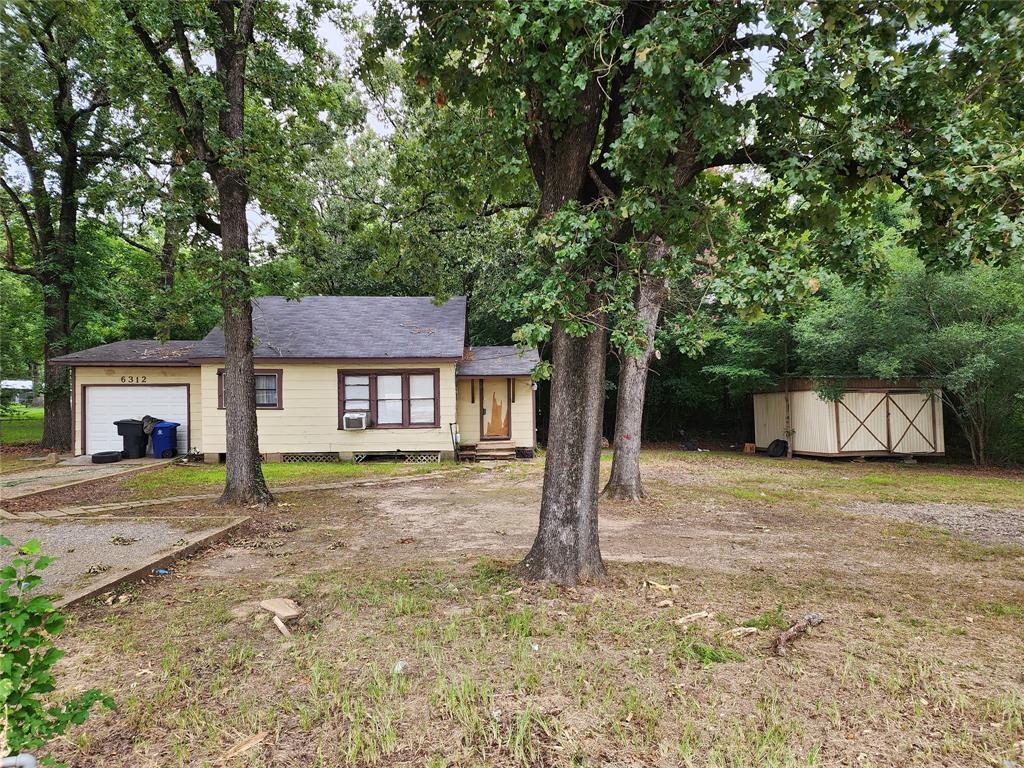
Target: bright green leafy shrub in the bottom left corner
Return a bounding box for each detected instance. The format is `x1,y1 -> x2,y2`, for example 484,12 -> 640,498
0,537 -> 114,757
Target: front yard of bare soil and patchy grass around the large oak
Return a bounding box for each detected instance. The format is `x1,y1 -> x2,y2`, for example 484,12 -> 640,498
24,452 -> 1024,768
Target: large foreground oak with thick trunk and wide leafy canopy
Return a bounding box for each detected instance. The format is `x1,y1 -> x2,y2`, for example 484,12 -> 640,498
389,0 -> 1024,584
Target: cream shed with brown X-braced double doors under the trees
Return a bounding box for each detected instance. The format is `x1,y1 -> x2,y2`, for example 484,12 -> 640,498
754,379 -> 946,456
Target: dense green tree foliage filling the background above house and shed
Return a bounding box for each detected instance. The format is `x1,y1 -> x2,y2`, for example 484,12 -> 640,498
0,2 -> 1024,463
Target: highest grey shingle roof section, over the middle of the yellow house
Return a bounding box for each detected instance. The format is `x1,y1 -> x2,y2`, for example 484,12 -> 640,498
193,296 -> 466,359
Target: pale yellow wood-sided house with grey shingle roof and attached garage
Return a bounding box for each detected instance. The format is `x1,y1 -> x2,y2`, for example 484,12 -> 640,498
57,296 -> 539,462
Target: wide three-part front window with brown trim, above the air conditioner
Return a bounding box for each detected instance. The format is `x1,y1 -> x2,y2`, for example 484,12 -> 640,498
338,369 -> 440,429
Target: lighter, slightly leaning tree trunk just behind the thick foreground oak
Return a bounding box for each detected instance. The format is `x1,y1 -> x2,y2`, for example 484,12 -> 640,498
601,237 -> 669,502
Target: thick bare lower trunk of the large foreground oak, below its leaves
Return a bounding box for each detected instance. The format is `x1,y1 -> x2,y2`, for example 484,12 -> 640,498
515,309 -> 607,586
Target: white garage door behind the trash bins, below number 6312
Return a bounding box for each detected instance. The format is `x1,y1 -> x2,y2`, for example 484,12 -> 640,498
84,385 -> 188,454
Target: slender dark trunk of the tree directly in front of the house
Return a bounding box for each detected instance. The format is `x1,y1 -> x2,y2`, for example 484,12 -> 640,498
212,0 -> 271,508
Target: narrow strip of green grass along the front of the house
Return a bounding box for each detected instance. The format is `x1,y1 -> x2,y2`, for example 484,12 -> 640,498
123,462 -> 468,496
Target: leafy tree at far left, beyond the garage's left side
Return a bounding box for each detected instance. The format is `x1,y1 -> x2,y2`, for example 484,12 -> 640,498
0,0 -> 138,452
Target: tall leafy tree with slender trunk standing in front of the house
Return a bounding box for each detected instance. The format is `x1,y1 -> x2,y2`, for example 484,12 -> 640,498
120,0 -> 351,506
